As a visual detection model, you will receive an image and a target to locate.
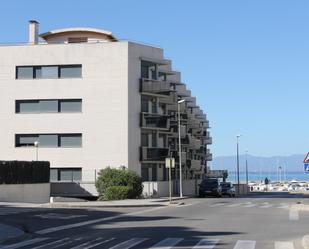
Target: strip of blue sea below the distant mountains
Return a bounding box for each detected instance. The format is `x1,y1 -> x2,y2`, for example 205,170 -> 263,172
227,171 -> 309,182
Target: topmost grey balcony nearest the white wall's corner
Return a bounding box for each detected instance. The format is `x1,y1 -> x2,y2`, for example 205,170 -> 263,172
141,78 -> 174,95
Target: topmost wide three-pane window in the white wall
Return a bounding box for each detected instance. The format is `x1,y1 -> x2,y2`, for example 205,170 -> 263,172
16,65 -> 82,79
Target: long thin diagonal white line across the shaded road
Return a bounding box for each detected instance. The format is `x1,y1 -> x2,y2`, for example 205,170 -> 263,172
36,206 -> 166,234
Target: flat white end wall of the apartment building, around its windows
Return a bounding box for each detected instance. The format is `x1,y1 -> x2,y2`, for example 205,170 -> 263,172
0,42 -> 129,181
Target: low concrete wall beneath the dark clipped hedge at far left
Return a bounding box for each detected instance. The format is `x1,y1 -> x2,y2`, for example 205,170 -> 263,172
0,183 -> 50,203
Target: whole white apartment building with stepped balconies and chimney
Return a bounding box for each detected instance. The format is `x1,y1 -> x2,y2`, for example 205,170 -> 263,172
0,21 -> 212,196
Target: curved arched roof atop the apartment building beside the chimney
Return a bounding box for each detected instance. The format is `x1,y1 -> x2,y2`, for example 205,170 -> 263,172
40,27 -> 117,41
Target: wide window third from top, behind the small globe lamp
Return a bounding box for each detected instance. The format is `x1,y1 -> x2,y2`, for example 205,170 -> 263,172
15,133 -> 82,148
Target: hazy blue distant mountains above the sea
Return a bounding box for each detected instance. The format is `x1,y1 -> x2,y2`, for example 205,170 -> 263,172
211,155 -> 304,172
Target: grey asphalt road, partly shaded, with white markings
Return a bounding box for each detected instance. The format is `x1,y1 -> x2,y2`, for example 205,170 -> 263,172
0,193 -> 309,249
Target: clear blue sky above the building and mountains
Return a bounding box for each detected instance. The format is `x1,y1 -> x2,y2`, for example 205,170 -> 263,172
0,0 -> 309,156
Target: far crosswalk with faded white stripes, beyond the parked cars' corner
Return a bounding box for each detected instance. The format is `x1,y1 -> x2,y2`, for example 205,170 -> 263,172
208,201 -> 290,209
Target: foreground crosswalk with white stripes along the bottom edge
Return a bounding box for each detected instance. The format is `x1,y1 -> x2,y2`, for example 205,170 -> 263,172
0,237 -> 303,249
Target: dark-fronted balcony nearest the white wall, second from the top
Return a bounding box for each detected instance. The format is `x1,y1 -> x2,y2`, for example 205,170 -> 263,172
141,112 -> 170,130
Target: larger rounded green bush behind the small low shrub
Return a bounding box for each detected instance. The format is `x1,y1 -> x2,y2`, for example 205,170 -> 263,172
96,167 -> 143,198
